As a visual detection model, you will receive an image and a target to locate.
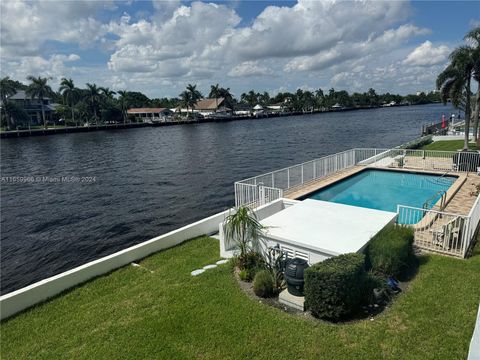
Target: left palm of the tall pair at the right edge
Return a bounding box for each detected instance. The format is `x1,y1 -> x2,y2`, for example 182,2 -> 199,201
437,46 -> 474,150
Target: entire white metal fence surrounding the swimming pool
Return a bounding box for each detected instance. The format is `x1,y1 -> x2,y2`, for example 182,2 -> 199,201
235,148 -> 480,257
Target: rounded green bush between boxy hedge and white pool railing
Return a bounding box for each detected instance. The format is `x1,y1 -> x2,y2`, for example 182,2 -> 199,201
366,225 -> 415,276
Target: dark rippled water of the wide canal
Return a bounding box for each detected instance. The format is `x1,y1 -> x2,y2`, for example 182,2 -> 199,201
0,105 -> 452,293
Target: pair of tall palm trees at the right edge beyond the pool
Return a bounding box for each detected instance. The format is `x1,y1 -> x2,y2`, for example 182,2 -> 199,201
437,27 -> 480,150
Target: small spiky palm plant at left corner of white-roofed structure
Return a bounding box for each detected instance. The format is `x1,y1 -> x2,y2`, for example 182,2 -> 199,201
223,206 -> 264,262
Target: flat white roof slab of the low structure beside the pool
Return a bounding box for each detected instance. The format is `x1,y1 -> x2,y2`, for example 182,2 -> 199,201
261,199 -> 397,256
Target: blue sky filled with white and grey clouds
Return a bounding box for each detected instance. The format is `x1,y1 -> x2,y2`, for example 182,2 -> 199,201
0,0 -> 480,97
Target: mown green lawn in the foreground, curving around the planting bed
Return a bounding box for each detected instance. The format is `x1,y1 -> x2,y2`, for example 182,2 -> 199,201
1,237 -> 480,360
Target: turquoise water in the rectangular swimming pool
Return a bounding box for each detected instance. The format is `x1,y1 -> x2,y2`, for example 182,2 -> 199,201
304,169 -> 457,223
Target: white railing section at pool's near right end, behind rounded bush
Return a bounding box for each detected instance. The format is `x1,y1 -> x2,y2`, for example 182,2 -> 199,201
397,205 -> 472,258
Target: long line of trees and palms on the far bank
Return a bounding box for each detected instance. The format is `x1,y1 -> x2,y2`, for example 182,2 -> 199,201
0,76 -> 440,128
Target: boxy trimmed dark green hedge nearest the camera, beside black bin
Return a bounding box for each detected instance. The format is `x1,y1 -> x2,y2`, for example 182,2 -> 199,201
305,254 -> 366,321
